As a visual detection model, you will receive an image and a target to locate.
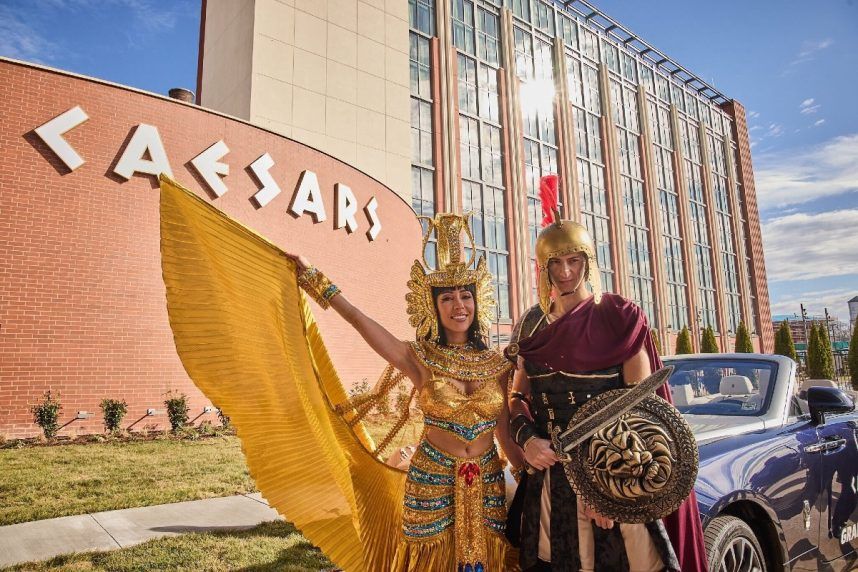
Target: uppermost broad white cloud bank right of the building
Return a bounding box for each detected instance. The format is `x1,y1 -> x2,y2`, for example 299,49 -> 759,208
754,134 -> 858,208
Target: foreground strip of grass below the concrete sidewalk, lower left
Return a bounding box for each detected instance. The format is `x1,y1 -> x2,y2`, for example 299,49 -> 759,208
4,522 -> 333,572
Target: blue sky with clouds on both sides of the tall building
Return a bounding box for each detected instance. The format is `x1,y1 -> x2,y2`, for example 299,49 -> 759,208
0,0 -> 858,319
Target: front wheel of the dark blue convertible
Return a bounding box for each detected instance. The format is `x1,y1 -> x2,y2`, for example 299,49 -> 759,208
704,516 -> 766,572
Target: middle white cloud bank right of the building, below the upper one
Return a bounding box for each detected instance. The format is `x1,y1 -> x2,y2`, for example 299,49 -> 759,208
762,209 -> 858,282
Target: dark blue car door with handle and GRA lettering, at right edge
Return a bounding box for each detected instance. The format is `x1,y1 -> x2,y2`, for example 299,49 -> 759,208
818,414 -> 858,570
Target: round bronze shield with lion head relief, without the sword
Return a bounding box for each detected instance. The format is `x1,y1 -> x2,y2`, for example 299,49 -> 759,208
563,389 -> 699,523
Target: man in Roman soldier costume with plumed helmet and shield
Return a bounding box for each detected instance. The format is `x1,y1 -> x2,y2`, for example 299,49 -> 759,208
506,176 -> 706,572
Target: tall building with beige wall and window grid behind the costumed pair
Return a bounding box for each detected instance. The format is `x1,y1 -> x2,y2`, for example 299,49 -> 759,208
198,0 -> 774,353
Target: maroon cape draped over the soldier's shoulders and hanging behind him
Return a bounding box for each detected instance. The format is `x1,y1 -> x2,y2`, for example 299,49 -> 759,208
518,293 -> 707,572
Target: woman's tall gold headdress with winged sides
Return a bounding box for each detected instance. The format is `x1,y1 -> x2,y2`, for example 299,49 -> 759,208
405,213 -> 495,340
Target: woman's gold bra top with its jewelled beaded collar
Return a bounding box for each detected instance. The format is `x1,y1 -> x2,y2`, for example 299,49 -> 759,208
411,341 -> 511,442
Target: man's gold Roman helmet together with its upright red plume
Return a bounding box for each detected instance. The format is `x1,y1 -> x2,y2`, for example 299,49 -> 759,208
536,175 -> 602,314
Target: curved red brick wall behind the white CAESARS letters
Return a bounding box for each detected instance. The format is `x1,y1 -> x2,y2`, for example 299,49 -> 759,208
0,60 -> 421,437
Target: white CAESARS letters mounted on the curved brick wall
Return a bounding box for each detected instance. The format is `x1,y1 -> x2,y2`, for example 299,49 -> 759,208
35,105 -> 381,241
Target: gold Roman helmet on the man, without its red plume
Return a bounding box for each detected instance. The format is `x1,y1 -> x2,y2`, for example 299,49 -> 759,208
536,217 -> 602,314
